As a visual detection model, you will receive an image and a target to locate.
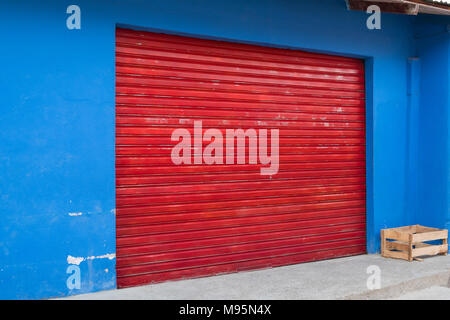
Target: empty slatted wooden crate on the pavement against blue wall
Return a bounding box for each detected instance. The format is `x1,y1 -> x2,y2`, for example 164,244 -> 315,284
381,225 -> 448,261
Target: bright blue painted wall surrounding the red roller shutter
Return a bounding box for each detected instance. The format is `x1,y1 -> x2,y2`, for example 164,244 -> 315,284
0,0 -> 449,299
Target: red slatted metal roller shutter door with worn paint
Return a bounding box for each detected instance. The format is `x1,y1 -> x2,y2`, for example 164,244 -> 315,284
116,29 -> 366,287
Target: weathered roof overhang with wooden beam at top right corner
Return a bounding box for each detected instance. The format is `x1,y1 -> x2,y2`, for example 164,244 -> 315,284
346,0 -> 450,15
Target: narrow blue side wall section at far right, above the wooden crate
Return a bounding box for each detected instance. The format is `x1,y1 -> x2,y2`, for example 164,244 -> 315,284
416,17 -> 450,229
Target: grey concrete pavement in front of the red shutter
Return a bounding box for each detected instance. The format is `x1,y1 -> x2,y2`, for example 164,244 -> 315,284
59,255 -> 450,300
